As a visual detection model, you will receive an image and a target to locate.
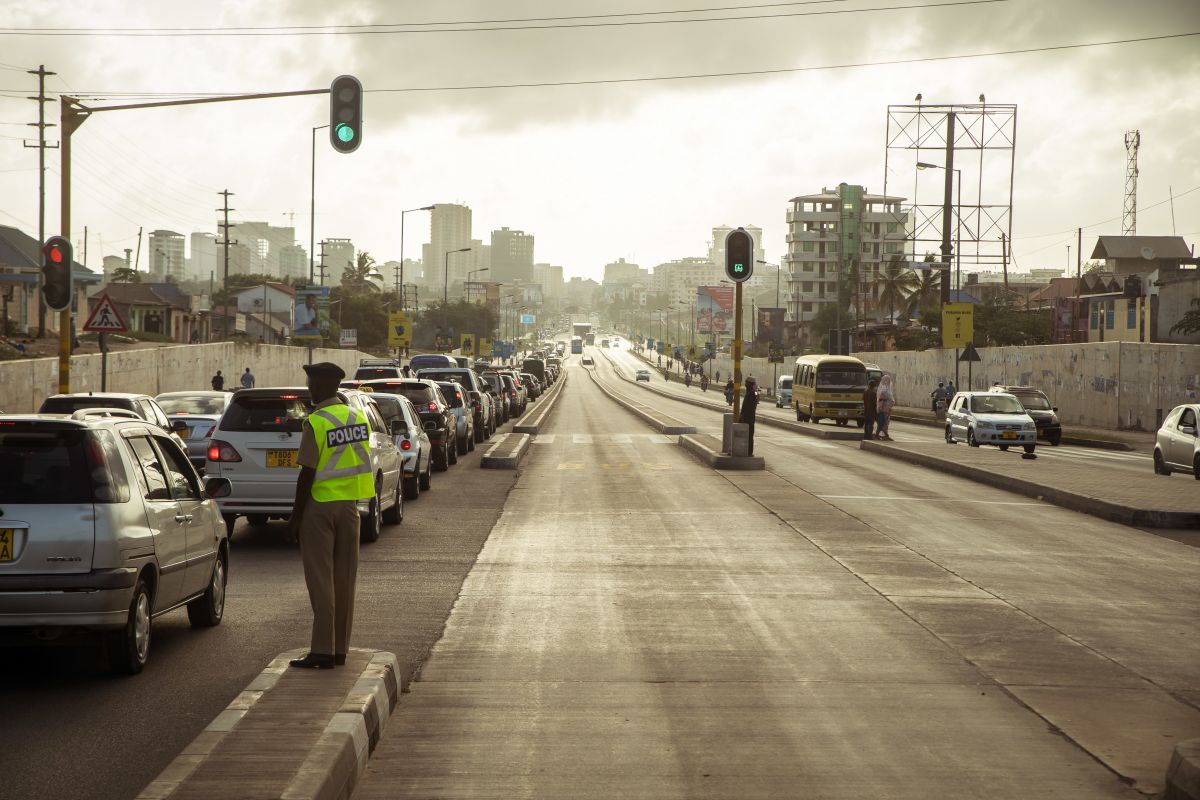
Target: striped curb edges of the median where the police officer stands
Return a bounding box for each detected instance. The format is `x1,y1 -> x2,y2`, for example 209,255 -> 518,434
137,648 -> 400,800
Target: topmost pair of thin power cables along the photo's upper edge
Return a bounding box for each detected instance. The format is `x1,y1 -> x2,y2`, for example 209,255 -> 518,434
0,0 -> 1009,38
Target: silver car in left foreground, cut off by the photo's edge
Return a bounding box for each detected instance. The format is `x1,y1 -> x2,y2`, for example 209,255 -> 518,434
0,409 -> 229,673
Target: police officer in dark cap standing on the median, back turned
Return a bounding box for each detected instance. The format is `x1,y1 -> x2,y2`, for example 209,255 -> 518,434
288,362 -> 374,669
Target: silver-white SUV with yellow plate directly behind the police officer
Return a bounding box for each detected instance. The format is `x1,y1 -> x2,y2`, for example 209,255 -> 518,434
204,386 -> 404,542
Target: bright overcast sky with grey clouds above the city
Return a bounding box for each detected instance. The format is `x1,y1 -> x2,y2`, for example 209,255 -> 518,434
0,0 -> 1200,279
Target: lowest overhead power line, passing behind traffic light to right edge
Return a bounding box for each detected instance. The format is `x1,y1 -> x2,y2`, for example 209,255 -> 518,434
14,31 -> 1200,101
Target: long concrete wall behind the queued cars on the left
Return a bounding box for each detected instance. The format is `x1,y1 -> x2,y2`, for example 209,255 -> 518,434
0,342 -> 370,414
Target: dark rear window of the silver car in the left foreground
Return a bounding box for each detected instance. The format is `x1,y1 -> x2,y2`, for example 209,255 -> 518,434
0,423 -> 125,505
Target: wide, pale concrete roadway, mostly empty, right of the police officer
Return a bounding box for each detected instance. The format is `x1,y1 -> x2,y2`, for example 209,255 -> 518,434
356,354 -> 1200,800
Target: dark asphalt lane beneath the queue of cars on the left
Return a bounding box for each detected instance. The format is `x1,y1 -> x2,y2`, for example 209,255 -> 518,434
0,412 -> 525,800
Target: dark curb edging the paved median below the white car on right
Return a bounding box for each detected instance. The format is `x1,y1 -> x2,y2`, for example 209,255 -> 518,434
858,440 -> 1200,528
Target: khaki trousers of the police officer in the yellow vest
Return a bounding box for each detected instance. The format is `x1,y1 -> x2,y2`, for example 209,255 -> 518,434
300,499 -> 359,655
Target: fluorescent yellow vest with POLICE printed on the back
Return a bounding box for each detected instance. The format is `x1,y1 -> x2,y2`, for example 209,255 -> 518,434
308,403 -> 374,503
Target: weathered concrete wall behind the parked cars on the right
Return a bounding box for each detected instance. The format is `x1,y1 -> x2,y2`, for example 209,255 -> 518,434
857,342 -> 1200,431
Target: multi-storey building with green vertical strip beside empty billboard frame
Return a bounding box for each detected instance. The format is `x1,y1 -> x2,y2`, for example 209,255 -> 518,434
784,184 -> 911,323
